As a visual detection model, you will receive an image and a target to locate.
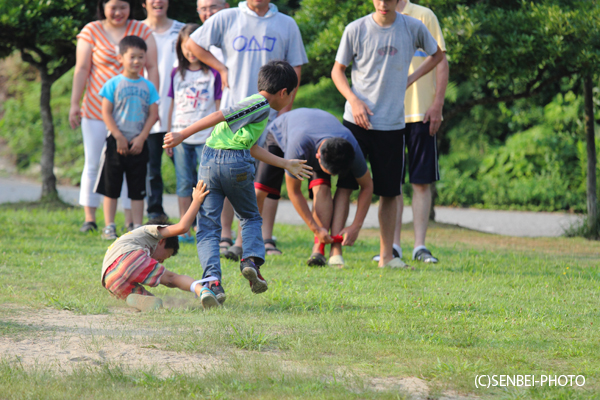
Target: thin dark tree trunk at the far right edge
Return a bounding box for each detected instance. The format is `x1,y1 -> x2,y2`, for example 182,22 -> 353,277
583,76 -> 598,229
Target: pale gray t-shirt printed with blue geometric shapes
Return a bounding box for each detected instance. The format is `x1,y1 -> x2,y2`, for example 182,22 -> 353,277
190,2 -> 308,109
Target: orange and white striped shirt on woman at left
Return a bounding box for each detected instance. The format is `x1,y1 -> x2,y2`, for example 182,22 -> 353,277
77,19 -> 152,120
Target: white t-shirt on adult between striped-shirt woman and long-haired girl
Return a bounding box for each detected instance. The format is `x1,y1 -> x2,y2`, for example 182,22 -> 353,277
150,20 -> 185,133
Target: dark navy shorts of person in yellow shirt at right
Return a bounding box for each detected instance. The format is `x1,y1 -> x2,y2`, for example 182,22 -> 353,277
402,122 -> 440,184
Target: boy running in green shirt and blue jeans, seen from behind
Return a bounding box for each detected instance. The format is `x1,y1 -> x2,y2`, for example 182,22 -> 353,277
163,61 -> 312,308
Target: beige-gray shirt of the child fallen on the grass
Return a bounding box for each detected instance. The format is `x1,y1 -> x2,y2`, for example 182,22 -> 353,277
100,225 -> 167,279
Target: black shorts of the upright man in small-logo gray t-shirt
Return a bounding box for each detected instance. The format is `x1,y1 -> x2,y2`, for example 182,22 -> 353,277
340,120 -> 404,197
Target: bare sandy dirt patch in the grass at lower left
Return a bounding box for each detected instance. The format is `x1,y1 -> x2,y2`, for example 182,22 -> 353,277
0,305 -> 223,376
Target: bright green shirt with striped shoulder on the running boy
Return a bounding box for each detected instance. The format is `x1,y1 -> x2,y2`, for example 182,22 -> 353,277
206,94 -> 271,150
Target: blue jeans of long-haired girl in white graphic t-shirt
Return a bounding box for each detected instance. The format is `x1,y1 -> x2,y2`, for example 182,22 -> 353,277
173,143 -> 204,197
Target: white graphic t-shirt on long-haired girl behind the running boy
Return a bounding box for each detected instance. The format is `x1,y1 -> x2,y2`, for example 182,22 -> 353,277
168,68 -> 221,145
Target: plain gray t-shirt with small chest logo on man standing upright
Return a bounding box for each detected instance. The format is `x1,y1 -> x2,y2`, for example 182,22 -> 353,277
335,13 -> 437,131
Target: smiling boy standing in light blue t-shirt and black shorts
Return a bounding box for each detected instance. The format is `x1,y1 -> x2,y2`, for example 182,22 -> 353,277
96,36 -> 159,240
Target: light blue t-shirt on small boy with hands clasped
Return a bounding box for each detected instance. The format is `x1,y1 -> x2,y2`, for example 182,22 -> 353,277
99,75 -> 160,141
